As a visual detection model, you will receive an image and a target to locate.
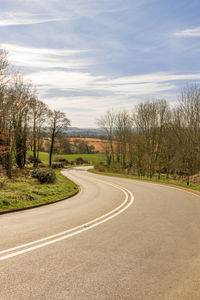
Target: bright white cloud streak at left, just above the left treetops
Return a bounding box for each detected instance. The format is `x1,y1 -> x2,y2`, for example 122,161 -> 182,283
2,44 -> 92,69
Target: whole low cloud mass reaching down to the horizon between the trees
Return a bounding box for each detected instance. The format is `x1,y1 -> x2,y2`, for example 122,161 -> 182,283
22,71 -> 200,127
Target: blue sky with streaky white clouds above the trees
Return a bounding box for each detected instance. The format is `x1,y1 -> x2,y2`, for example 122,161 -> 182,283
0,0 -> 200,128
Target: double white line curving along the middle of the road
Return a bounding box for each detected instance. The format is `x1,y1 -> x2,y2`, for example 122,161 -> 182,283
0,178 -> 134,261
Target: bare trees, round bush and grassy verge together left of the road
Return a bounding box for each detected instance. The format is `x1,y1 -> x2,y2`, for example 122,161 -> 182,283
0,49 -> 78,211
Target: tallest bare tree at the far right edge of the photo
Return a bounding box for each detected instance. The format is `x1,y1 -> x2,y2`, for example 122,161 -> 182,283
173,85 -> 200,184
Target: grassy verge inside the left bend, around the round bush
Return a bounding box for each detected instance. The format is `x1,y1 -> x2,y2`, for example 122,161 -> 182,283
0,170 -> 78,211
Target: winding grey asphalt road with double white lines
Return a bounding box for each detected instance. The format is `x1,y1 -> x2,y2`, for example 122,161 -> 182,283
0,167 -> 200,300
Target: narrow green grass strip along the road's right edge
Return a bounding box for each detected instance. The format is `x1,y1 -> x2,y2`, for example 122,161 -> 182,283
89,169 -> 200,192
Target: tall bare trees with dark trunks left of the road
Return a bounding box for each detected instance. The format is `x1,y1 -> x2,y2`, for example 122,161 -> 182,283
0,49 -> 70,178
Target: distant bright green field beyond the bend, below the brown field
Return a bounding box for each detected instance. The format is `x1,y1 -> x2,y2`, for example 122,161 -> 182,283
27,151 -> 105,164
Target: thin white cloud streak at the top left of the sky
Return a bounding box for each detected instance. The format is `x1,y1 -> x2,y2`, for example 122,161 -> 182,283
0,4 -> 125,27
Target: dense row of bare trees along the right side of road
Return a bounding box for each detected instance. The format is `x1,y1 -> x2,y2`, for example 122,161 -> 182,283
98,85 -> 200,184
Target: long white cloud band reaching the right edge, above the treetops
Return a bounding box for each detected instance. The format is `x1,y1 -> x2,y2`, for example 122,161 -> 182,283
23,70 -> 200,96
